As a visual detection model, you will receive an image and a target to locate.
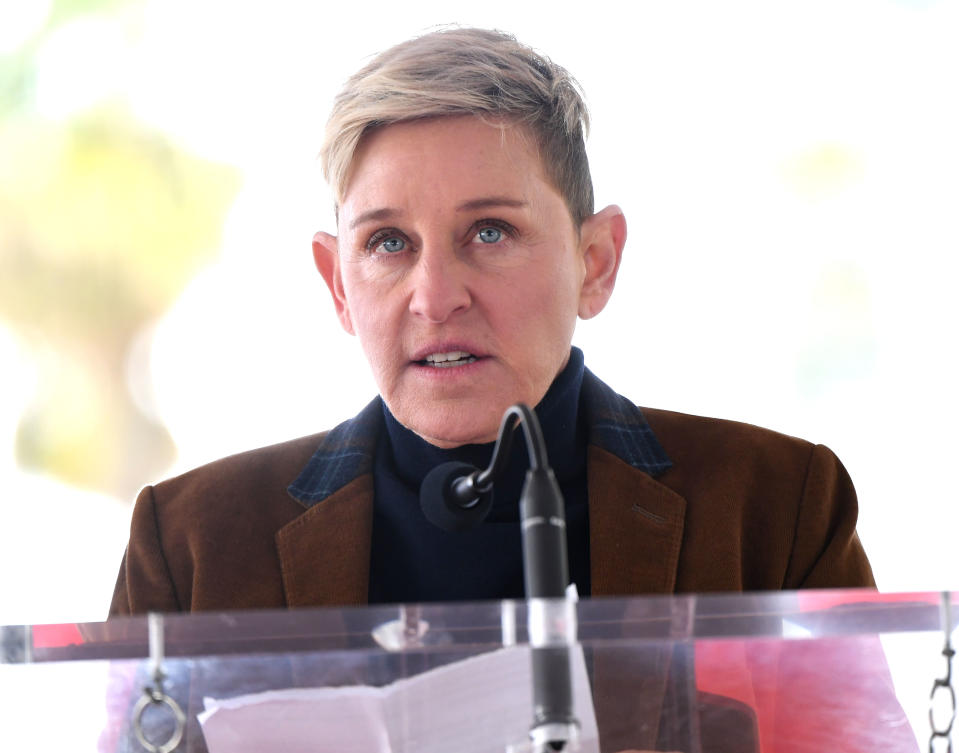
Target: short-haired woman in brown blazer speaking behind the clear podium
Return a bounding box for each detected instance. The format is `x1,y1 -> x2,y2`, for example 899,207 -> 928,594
111,29 -> 873,614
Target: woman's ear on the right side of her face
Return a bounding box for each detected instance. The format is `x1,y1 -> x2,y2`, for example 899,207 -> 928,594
579,205 -> 626,319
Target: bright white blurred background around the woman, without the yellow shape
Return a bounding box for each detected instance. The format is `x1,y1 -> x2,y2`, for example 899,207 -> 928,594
0,0 -> 959,623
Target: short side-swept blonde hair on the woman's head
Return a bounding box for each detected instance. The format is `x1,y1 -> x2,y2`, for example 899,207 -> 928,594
320,28 -> 593,227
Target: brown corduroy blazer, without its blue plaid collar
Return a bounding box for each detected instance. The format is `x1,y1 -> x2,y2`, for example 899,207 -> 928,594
110,402 -> 874,615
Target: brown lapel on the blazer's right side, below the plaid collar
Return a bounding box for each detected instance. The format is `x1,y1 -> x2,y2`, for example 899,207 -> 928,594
587,445 -> 686,596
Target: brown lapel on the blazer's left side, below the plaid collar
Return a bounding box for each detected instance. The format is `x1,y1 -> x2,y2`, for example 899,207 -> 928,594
276,473 -> 373,607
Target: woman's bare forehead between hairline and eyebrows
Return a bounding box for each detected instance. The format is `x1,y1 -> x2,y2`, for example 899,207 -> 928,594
340,116 -> 558,219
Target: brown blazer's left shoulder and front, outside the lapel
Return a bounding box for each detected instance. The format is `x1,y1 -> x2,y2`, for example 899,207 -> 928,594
111,434 -> 332,614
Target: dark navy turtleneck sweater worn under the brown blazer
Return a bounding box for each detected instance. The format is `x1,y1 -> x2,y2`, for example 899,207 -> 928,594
369,348 -> 589,604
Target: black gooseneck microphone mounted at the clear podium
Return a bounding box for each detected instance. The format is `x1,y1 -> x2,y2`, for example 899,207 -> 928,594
420,403 -> 579,751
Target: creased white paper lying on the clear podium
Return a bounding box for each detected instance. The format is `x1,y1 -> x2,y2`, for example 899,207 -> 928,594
199,646 -> 599,753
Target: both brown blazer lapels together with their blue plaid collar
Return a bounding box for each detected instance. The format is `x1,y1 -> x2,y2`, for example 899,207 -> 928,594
276,369 -> 686,607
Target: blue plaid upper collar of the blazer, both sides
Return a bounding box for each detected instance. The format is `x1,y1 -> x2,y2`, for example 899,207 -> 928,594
287,369 -> 672,507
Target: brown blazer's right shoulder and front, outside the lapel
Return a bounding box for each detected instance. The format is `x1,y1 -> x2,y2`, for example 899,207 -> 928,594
643,409 -> 874,591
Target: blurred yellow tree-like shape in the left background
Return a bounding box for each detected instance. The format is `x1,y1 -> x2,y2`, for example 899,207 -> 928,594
0,104 -> 240,497
